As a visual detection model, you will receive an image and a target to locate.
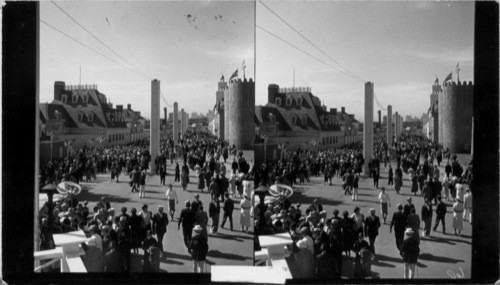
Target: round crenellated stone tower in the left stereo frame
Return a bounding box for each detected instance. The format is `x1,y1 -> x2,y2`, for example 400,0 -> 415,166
224,78 -> 255,150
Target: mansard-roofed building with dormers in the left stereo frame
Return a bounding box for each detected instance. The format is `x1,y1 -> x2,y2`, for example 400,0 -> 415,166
40,81 -> 147,163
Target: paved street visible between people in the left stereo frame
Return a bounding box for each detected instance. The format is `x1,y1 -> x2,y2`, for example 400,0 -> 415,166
77,151 -> 253,272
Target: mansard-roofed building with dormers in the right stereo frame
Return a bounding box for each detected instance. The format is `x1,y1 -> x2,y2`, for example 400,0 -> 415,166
255,84 -> 360,153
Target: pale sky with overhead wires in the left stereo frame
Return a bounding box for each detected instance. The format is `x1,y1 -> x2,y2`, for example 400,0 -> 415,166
40,1 -> 255,117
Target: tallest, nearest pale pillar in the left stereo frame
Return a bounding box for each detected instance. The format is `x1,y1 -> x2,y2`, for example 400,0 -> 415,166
149,79 -> 160,173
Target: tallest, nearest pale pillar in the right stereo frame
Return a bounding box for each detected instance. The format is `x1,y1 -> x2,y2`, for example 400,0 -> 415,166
363,82 -> 373,176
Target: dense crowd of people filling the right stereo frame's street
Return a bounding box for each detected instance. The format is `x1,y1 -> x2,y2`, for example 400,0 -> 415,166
254,130 -> 473,279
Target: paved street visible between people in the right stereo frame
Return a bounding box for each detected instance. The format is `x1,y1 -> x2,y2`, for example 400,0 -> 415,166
288,156 -> 472,278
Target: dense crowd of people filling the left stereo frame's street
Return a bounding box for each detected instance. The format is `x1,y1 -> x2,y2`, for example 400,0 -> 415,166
39,128 -> 253,272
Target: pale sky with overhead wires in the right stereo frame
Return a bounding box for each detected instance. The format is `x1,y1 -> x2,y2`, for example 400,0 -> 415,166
256,1 -> 474,121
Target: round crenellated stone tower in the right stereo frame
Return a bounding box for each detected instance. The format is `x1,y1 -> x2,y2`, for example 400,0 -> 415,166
438,81 -> 474,153
